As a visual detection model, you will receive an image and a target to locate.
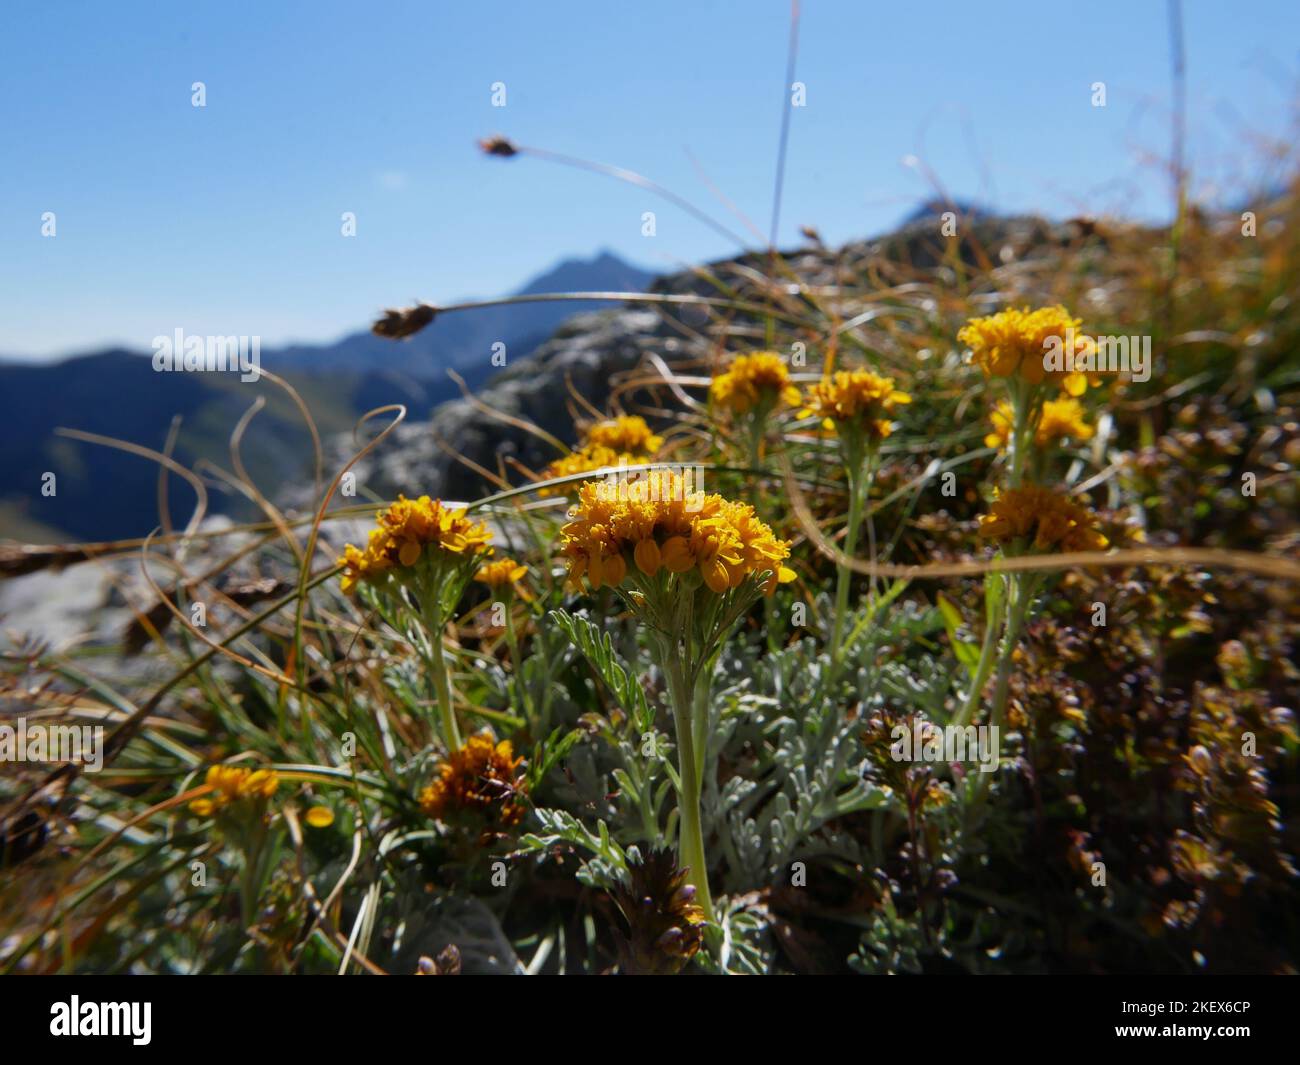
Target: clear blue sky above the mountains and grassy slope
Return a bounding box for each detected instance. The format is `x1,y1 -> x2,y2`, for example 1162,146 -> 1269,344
0,0 -> 1300,358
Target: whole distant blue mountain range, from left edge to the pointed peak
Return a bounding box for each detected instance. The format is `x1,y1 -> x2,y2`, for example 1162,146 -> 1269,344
0,252 -> 650,541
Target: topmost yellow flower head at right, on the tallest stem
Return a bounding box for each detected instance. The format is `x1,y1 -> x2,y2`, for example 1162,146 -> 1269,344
957,306 -> 1096,397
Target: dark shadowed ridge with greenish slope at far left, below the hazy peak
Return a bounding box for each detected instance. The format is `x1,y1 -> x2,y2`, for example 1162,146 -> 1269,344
0,351 -> 363,540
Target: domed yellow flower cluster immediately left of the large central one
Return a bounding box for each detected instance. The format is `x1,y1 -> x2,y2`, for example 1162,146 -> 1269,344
339,495 -> 493,592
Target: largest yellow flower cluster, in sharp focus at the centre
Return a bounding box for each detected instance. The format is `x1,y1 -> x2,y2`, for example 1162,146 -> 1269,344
560,469 -> 794,596
